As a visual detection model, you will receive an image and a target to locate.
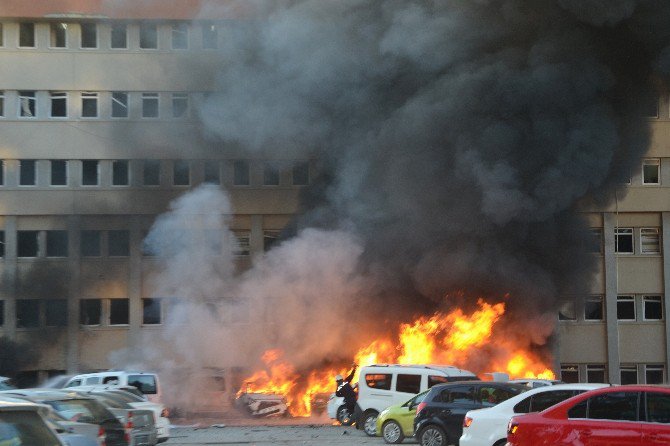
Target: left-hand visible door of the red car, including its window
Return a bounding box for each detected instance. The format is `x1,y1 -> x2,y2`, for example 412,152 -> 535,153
559,391 -> 642,446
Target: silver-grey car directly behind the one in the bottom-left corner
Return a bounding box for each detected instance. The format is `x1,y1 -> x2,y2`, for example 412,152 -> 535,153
0,389 -> 129,446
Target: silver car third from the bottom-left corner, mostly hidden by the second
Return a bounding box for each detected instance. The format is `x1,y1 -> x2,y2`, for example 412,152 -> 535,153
72,387 -> 158,446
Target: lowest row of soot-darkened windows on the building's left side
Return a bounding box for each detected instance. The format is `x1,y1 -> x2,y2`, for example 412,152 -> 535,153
0,297 -> 163,329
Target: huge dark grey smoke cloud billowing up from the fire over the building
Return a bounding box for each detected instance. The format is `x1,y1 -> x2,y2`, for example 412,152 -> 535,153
117,0 -> 670,400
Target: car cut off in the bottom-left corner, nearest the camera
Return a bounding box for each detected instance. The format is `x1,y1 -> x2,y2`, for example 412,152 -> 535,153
0,399 -> 66,446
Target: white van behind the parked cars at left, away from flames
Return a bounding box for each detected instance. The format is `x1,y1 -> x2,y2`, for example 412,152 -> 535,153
63,370 -> 161,403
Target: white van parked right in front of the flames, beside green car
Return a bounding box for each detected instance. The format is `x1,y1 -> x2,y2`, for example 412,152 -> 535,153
357,364 -> 479,437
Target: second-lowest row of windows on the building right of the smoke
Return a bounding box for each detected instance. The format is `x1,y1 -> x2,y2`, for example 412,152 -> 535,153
558,294 -> 663,321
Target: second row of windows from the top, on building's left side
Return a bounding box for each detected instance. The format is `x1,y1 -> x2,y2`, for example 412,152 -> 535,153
0,90 -> 190,119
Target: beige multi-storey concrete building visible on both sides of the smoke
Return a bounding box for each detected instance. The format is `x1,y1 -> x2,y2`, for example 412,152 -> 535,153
0,0 -> 670,384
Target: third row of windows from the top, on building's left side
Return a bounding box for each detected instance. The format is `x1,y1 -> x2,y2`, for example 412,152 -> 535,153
0,159 -> 309,186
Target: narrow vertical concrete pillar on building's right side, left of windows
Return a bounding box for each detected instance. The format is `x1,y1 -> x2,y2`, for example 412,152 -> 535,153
603,212 -> 621,384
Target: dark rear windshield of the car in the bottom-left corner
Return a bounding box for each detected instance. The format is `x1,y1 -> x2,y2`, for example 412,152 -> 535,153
0,411 -> 61,446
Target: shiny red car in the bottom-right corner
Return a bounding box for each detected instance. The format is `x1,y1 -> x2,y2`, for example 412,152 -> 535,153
507,385 -> 670,446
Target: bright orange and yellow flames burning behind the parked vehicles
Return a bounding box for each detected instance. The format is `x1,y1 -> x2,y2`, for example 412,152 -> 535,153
239,299 -> 554,416
